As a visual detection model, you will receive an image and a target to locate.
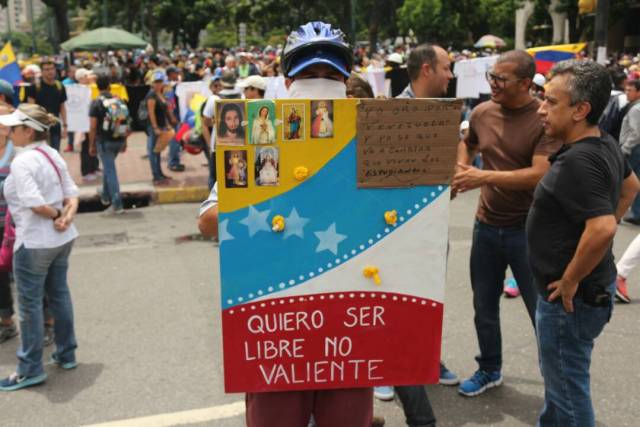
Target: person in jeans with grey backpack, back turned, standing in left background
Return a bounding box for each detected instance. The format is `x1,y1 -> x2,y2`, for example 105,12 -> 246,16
89,75 -> 127,214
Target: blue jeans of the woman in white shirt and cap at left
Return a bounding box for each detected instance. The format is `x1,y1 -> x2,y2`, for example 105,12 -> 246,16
13,241 -> 77,377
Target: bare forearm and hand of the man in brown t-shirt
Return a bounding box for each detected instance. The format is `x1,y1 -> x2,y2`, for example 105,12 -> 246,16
453,154 -> 551,192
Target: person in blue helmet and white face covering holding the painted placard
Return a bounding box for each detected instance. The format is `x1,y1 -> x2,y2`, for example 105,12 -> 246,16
246,22 -> 373,427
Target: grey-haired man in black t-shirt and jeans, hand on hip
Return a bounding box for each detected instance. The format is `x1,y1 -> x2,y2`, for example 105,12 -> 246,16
527,60 -> 640,427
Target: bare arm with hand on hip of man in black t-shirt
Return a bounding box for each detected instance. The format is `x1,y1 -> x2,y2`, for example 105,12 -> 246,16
547,215 -> 617,313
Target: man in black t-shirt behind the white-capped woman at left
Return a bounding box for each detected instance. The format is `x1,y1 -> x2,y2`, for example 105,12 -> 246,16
26,60 -> 67,150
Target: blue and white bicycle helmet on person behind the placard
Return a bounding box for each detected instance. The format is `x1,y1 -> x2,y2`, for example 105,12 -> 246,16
282,21 -> 353,78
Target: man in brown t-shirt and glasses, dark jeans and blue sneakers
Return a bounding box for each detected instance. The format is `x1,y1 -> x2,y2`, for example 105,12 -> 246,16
452,50 -> 559,396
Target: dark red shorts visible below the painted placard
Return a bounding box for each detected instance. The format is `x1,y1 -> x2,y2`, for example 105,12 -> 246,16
245,388 -> 373,427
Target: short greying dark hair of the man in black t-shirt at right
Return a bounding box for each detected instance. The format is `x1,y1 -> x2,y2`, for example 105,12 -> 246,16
551,59 -> 611,125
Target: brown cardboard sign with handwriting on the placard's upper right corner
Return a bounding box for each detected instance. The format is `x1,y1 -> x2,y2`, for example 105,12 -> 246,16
357,99 -> 462,188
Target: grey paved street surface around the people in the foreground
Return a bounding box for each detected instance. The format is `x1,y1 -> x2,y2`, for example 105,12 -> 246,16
0,192 -> 640,427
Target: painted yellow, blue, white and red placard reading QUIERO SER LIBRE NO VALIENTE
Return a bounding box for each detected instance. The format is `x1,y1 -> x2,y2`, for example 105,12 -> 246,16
216,99 -> 457,392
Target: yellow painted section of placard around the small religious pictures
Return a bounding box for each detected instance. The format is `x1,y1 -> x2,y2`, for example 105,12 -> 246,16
216,99 -> 358,212
